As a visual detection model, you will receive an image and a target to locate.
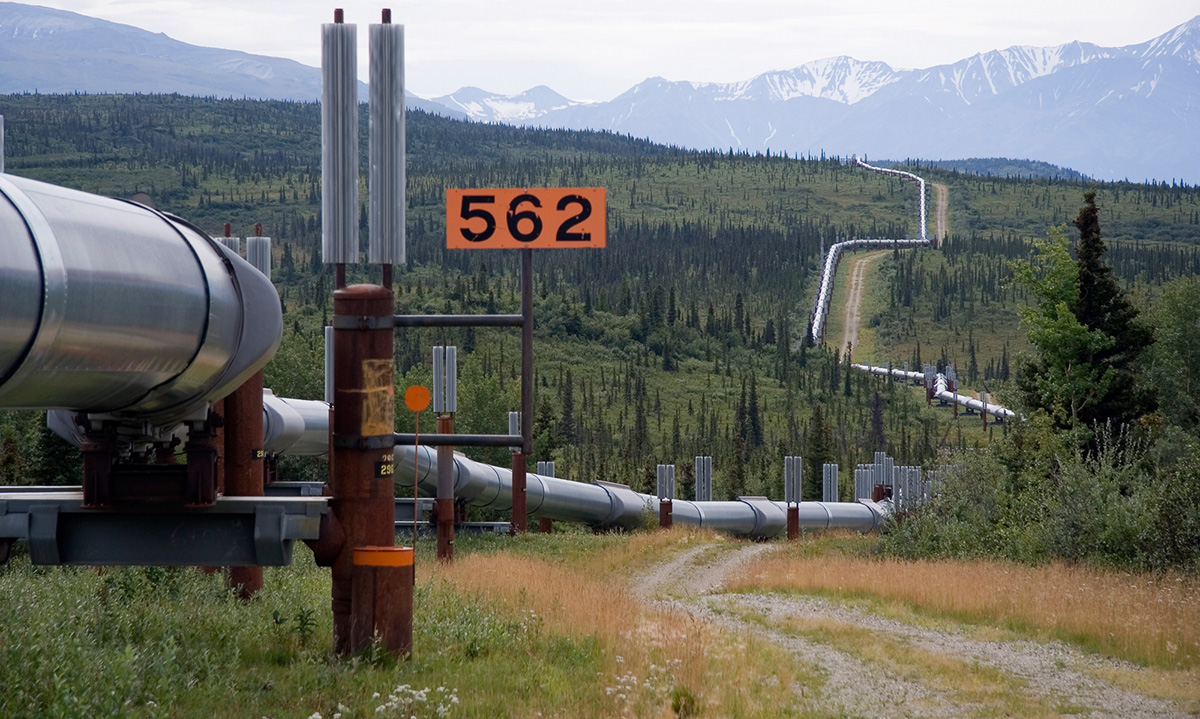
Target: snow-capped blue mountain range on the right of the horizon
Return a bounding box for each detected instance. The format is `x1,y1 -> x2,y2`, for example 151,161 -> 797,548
438,17 -> 1200,184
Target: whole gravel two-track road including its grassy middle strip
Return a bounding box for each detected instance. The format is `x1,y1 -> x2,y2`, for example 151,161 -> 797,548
632,541 -> 1200,719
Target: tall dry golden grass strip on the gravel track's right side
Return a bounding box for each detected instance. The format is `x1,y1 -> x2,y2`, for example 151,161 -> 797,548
730,556 -> 1200,667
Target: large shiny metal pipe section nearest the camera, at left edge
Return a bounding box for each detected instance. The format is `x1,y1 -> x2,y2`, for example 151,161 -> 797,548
0,175 -> 283,425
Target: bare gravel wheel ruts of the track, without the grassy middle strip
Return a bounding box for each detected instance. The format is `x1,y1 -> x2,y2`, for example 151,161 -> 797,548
632,544 -> 1195,719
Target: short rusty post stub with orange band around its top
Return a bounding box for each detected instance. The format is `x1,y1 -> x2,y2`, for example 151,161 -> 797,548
350,546 -> 415,658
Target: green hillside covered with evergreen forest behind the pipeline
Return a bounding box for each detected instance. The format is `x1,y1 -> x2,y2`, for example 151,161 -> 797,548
0,95 -> 1200,562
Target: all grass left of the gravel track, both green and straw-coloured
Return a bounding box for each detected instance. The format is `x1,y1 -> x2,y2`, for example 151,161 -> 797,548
0,527 -> 828,719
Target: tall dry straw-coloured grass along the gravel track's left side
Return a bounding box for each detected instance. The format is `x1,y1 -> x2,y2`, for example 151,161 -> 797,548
426,533 -> 811,717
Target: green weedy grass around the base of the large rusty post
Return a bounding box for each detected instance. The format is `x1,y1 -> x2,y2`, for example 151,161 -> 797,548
0,551 -> 604,719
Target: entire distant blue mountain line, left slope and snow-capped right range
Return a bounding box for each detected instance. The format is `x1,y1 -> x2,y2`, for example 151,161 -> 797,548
0,2 -> 1200,184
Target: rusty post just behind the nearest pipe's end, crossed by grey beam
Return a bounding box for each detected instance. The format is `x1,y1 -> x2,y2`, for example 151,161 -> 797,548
225,372 -> 263,599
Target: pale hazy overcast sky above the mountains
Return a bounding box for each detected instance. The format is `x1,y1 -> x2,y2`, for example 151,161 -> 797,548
28,0 -> 1200,100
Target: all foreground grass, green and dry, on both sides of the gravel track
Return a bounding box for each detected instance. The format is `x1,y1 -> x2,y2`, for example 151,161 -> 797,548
0,528 -> 1200,719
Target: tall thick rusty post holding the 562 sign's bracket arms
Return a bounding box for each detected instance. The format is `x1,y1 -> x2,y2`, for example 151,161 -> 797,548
329,284 -> 396,653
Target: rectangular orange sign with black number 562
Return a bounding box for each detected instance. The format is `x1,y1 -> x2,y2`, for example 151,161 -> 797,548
446,187 -> 607,250
